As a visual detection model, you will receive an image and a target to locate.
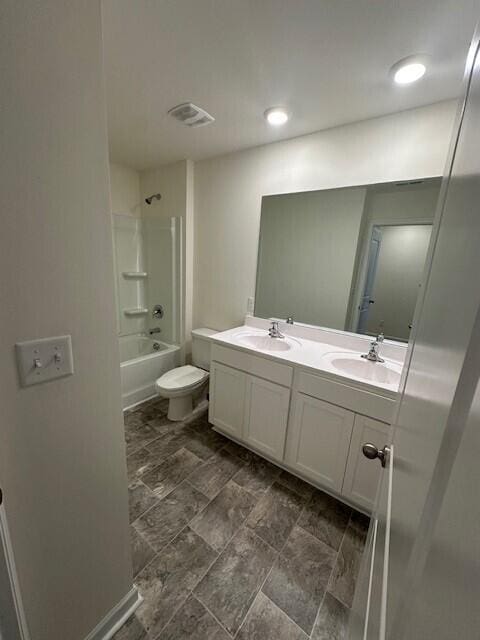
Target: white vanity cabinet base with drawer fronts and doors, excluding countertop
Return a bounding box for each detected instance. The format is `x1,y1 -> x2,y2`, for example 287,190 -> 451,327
209,344 -> 394,511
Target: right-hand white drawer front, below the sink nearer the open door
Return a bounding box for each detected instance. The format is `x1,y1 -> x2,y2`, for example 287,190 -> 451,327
295,371 -> 395,422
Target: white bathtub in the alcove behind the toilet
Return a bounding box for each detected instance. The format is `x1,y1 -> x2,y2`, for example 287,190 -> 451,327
119,335 -> 180,409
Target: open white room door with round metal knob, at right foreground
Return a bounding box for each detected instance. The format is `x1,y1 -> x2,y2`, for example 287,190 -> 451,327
349,33 -> 480,640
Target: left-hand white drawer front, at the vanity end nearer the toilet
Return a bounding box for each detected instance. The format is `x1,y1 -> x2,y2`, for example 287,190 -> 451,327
211,343 -> 293,387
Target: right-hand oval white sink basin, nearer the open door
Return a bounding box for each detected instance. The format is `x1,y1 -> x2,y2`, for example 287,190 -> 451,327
324,352 -> 402,385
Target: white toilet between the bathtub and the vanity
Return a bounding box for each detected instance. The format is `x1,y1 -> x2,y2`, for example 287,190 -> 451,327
155,329 -> 216,420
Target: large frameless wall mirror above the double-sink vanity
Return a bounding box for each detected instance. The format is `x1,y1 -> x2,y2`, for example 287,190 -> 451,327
255,178 -> 440,341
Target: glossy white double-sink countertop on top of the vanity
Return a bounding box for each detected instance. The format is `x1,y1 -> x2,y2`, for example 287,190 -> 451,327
211,321 -> 406,397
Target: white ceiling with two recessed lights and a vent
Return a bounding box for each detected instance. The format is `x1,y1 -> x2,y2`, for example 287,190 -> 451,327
103,0 -> 480,169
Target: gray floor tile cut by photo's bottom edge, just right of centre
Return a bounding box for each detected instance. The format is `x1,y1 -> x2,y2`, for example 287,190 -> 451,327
236,593 -> 308,640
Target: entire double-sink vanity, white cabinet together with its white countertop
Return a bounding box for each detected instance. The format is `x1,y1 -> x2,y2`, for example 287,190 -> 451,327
209,318 -> 405,511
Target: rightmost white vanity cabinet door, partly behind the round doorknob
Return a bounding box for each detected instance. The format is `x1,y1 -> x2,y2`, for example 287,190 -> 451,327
342,414 -> 389,511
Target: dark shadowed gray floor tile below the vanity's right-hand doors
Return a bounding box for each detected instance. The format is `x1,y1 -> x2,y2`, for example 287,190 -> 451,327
298,490 -> 352,551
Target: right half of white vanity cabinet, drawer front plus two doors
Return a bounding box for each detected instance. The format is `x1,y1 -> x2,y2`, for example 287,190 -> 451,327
285,369 -> 393,510
